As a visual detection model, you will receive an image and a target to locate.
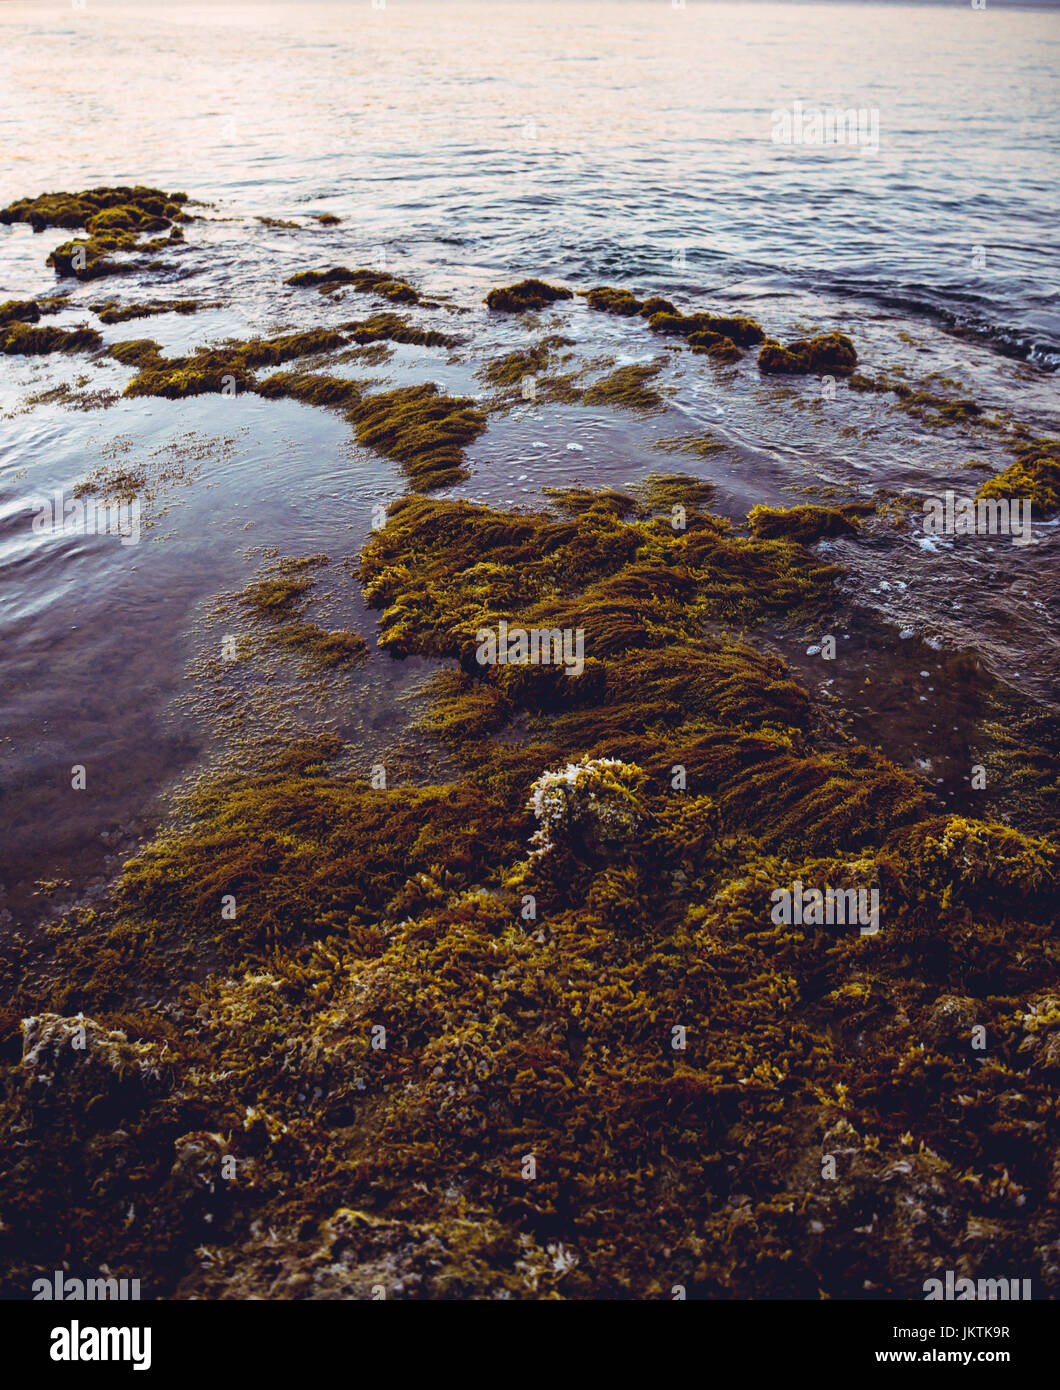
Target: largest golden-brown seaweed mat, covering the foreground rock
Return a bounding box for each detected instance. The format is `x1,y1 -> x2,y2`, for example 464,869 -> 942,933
0,480 -> 1060,1300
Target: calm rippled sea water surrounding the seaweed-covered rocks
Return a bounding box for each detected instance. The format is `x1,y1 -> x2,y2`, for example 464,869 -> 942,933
0,0 -> 1060,919
